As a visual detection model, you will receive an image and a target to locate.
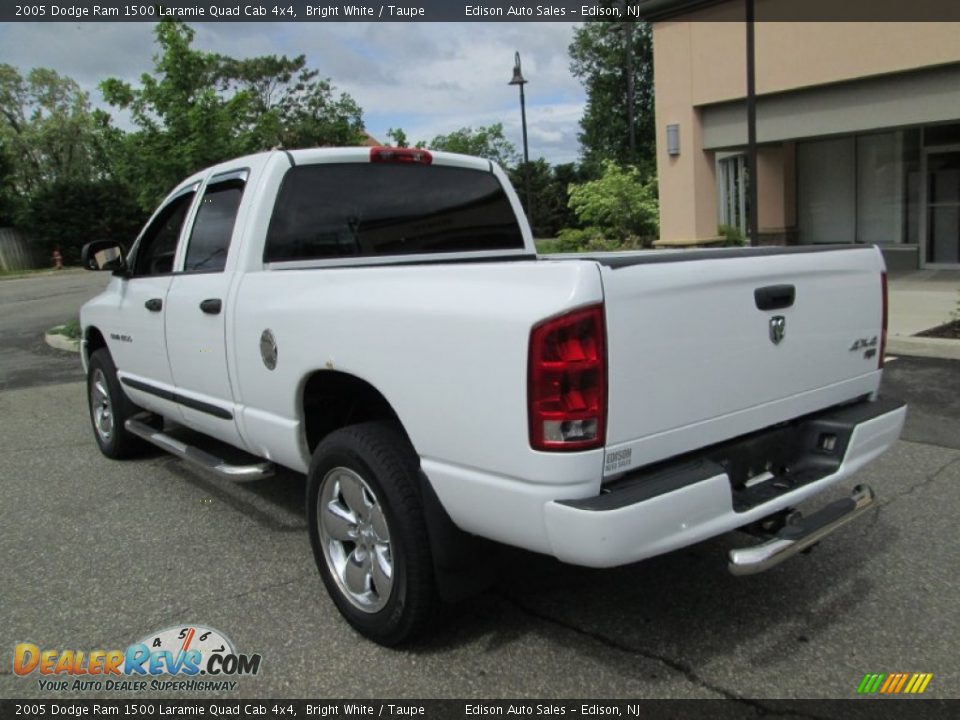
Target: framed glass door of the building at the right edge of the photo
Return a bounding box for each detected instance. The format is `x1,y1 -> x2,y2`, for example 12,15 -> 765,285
923,148 -> 960,268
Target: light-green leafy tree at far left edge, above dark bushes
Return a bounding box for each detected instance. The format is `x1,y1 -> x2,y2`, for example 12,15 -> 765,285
0,64 -> 106,197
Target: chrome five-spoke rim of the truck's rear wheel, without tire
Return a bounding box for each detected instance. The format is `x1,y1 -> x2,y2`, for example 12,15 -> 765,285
317,467 -> 393,613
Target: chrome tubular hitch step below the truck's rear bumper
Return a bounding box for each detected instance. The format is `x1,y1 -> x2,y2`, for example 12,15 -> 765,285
728,485 -> 876,575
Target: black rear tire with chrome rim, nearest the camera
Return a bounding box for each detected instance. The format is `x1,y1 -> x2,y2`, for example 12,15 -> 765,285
307,422 -> 436,646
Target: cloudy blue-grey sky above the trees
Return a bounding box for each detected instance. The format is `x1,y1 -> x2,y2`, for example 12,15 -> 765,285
0,22 -> 584,163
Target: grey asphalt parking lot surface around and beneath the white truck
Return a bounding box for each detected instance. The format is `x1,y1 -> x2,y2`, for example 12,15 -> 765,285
0,274 -> 960,699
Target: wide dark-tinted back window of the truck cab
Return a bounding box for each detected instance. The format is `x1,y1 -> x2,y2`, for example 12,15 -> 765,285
264,163 -> 524,262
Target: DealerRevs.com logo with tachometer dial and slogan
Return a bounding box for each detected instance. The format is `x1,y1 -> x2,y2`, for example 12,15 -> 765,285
13,625 -> 262,693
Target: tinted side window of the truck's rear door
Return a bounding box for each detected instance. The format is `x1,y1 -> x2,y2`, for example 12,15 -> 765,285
183,180 -> 243,272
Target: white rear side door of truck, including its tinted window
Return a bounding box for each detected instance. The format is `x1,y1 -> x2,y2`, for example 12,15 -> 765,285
166,169 -> 248,445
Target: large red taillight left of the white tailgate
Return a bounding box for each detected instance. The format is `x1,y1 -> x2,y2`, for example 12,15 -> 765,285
527,305 -> 607,450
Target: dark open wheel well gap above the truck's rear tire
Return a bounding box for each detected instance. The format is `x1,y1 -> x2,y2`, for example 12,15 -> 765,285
303,370 -> 402,453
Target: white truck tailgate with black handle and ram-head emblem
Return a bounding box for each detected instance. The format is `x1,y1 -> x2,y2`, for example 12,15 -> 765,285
596,246 -> 883,478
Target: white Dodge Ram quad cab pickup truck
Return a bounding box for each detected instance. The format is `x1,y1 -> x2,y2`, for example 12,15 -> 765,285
81,147 -> 906,644
